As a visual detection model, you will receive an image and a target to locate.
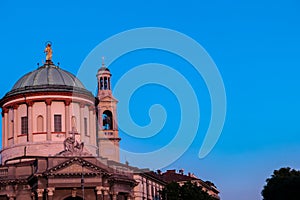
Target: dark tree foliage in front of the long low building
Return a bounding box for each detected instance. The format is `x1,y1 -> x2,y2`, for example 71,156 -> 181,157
161,182 -> 215,200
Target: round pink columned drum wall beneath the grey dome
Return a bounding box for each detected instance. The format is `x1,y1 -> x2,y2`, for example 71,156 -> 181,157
1,95 -> 98,162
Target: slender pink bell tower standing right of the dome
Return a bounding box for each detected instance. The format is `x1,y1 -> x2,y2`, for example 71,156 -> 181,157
97,59 -> 121,162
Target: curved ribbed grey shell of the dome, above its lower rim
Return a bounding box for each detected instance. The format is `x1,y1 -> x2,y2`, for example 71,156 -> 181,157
12,64 -> 85,90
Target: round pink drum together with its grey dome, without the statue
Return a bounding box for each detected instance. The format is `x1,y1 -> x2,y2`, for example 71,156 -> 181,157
0,65 -> 98,163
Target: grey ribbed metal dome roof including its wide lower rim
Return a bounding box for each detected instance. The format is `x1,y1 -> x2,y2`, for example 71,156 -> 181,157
5,63 -> 91,97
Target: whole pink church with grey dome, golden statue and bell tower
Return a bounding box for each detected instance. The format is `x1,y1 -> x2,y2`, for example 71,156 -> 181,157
0,44 -> 220,200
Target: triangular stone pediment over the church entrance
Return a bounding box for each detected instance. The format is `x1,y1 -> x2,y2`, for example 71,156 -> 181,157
45,157 -> 108,175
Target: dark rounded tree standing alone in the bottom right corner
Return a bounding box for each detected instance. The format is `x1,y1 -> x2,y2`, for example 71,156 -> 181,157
261,167 -> 300,200
